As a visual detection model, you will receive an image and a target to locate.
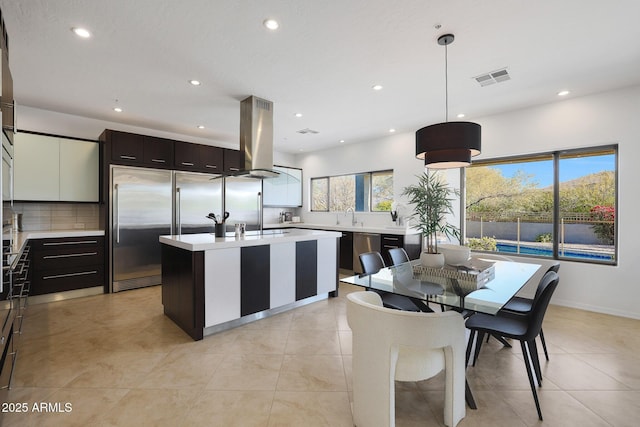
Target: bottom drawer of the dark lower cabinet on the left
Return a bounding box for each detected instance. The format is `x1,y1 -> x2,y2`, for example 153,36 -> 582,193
30,265 -> 104,295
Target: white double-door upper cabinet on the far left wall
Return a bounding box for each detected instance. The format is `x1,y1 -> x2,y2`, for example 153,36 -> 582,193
14,133 -> 99,202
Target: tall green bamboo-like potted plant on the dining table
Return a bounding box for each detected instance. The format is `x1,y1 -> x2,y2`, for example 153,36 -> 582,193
402,171 -> 460,267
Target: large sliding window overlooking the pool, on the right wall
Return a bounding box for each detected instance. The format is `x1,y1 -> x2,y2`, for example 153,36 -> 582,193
464,146 -> 617,264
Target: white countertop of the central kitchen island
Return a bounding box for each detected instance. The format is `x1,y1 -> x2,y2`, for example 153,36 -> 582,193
160,228 -> 341,252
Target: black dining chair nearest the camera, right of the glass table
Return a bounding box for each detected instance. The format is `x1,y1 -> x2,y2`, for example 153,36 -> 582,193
465,271 -> 560,421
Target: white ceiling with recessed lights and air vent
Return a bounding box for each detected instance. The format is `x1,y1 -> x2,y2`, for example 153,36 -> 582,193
0,0 -> 640,153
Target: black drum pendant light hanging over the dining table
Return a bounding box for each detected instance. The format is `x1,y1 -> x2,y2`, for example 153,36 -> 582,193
416,34 -> 481,169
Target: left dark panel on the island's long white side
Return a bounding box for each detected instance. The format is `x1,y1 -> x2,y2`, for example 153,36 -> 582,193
240,245 -> 271,316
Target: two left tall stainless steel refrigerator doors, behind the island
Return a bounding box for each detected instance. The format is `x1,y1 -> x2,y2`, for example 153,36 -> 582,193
109,166 -> 222,292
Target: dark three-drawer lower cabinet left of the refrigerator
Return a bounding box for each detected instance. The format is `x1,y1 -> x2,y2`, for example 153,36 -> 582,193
29,236 -> 105,295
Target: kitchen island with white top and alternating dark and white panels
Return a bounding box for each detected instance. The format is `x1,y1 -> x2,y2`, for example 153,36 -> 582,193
160,229 -> 341,340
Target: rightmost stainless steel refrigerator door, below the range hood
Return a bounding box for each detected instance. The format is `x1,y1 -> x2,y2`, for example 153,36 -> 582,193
224,177 -> 262,232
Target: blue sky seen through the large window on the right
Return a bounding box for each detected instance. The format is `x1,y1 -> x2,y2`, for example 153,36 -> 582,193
491,154 -> 616,188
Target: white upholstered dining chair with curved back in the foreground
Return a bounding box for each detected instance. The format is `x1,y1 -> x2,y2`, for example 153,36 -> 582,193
347,292 -> 466,427
